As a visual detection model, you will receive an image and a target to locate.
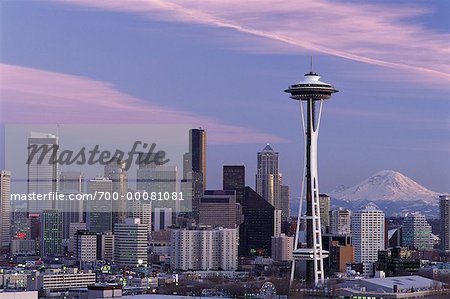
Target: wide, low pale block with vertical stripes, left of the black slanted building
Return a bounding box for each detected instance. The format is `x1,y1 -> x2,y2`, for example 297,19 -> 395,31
170,228 -> 238,271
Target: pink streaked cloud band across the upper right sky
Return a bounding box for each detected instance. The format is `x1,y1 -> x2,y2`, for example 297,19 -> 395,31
54,0 -> 450,86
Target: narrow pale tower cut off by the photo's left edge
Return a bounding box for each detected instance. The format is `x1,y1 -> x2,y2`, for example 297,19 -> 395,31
0,170 -> 11,250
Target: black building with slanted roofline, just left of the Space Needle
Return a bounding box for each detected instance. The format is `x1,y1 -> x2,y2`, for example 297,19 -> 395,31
239,187 -> 275,256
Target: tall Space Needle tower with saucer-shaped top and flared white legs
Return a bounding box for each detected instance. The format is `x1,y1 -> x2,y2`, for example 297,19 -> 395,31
285,59 -> 338,287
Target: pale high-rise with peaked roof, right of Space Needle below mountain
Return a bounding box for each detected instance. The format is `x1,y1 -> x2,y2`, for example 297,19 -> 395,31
351,203 -> 385,276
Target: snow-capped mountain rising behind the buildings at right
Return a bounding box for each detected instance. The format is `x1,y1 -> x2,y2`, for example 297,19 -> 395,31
330,170 -> 439,216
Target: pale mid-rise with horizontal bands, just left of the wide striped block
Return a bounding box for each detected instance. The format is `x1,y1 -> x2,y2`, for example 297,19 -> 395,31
114,218 -> 148,267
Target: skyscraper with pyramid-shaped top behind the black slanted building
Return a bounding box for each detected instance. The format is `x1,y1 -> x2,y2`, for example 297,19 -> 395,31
256,144 -> 281,210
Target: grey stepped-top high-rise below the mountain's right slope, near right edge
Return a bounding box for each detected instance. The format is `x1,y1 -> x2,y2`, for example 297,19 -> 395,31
402,213 -> 433,250
